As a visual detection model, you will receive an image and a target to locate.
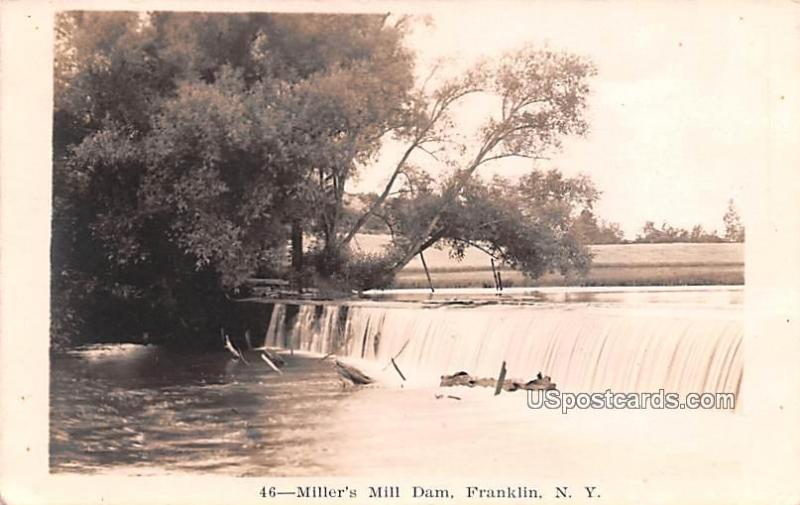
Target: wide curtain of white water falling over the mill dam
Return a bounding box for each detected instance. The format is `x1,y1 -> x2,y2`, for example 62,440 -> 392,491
266,302 -> 743,393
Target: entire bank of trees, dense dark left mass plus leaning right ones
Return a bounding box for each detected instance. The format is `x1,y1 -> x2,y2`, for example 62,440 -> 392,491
52,12 -> 598,348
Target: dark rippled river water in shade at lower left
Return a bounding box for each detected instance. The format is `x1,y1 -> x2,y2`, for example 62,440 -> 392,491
50,344 -> 347,476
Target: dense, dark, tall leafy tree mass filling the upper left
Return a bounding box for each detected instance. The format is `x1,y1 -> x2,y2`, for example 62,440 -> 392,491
53,12 -> 412,344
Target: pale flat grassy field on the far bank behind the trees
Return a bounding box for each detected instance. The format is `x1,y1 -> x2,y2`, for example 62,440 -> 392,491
356,235 -> 744,288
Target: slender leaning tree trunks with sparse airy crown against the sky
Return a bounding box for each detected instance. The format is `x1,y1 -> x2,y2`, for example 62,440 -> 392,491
330,47 -> 595,282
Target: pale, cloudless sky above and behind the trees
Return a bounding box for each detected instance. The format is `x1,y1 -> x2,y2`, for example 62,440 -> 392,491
355,2 -> 770,238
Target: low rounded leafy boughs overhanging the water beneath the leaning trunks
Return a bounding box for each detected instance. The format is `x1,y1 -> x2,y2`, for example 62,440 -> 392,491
388,170 -> 598,278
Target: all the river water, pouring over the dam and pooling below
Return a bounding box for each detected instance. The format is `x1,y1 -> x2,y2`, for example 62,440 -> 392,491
50,288 -> 743,476
